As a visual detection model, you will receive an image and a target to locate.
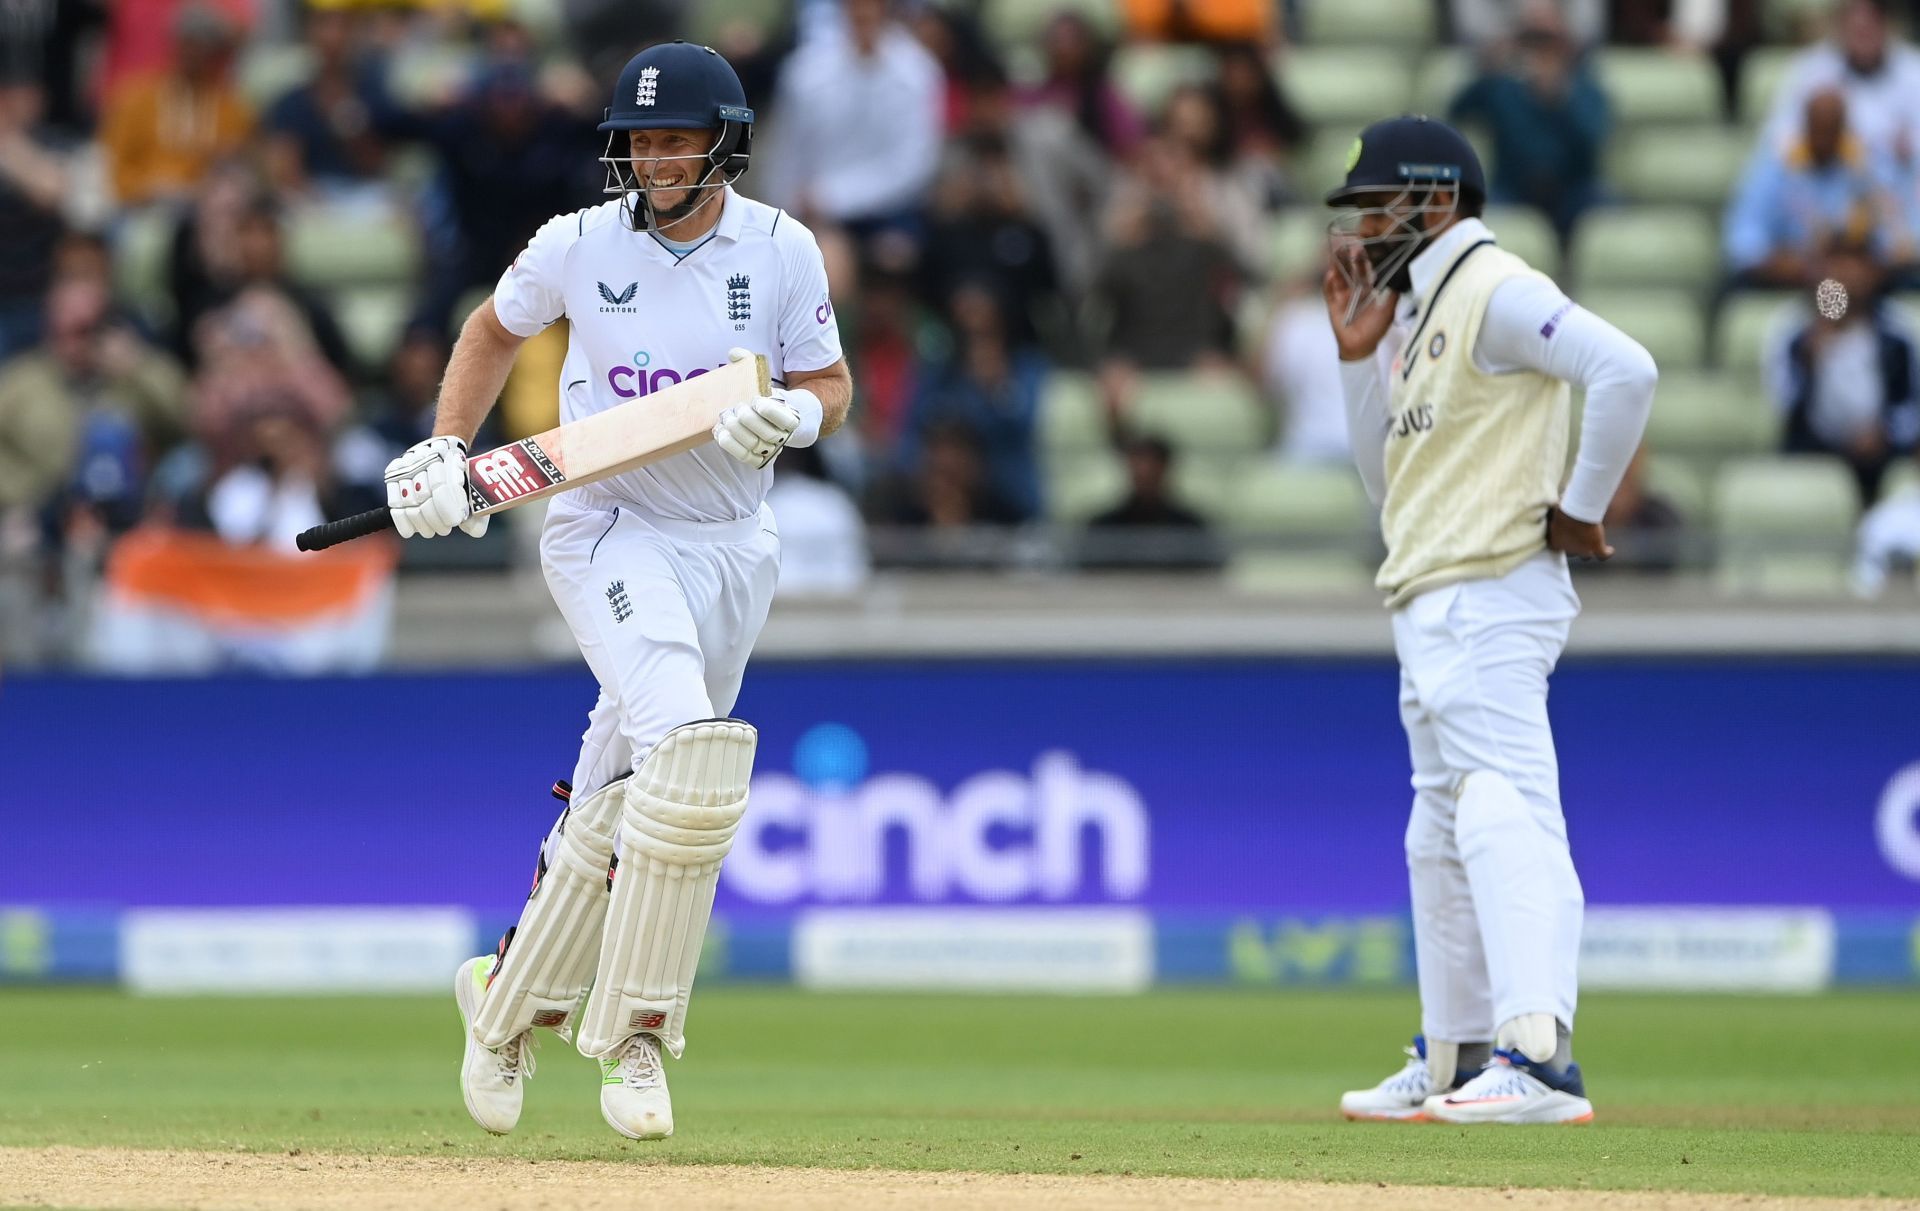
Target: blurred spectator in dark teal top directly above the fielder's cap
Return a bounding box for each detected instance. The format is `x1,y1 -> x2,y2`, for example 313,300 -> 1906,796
1450,4 -> 1613,242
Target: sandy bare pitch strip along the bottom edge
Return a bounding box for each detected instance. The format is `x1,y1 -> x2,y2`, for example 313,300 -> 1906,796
0,1148 -> 1920,1211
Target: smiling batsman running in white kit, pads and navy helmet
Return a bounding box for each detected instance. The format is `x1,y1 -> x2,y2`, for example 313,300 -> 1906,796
386,42 -> 852,1140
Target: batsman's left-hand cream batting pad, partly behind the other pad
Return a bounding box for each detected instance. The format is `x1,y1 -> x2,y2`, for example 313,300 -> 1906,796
472,779 -> 626,1048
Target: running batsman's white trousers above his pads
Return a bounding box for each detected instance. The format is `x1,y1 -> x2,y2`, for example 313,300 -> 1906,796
540,495 -> 780,821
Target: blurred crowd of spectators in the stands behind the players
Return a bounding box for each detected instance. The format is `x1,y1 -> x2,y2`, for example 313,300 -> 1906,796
0,0 -> 1920,664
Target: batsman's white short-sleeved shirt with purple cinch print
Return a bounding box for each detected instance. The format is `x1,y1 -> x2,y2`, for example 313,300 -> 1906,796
493,188 -> 841,522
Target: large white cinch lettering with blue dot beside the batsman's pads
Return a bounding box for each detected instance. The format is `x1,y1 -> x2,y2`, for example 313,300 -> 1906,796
720,724 -> 1150,906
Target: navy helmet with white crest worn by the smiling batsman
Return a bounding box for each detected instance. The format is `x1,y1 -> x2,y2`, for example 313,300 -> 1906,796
599,42 -> 753,230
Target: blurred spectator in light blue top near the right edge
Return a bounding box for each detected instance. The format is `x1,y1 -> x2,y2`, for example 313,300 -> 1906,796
1726,88 -> 1914,288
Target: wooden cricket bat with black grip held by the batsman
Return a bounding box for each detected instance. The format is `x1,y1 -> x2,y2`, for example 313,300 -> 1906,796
294,355 -> 774,551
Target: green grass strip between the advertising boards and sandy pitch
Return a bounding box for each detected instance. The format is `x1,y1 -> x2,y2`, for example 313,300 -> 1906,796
0,986 -> 1920,1198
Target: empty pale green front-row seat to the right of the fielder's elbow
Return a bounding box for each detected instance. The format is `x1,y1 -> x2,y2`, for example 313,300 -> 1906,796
1715,455 -> 1859,597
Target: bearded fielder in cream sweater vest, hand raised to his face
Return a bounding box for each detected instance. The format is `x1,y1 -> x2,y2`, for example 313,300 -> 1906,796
1325,117 -> 1657,1123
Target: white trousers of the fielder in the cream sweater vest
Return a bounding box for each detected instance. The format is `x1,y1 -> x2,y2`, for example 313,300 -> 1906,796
1394,551 -> 1586,1042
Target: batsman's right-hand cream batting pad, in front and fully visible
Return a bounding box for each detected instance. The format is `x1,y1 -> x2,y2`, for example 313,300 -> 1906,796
578,720 -> 760,1057
